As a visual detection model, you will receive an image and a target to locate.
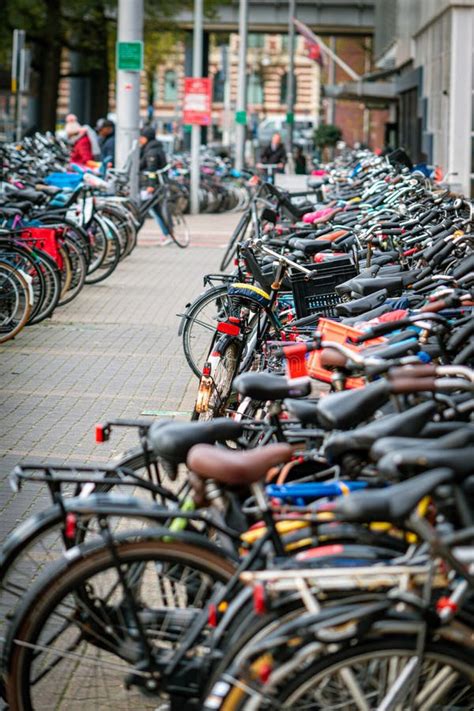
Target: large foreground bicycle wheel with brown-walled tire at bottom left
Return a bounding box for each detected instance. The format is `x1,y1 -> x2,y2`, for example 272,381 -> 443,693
6,538 -> 234,711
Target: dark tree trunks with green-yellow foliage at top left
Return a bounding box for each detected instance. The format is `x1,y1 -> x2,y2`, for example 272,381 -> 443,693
0,0 -> 224,131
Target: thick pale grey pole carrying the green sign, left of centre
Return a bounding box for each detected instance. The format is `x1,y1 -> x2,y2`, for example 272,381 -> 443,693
115,0 -> 143,199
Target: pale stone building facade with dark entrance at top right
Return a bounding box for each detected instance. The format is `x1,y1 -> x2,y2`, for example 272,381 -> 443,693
375,0 -> 474,196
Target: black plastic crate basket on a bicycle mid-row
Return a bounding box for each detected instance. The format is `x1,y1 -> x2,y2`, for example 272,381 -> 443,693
290,257 -> 357,318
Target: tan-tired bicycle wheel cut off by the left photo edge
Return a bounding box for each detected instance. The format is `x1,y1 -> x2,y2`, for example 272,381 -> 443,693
0,261 -> 31,343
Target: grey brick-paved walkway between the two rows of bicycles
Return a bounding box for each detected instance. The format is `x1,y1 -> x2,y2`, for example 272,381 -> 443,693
0,214 -> 239,540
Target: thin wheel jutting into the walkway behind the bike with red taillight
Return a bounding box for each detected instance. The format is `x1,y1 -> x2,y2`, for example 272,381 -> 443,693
180,286 -> 232,378
